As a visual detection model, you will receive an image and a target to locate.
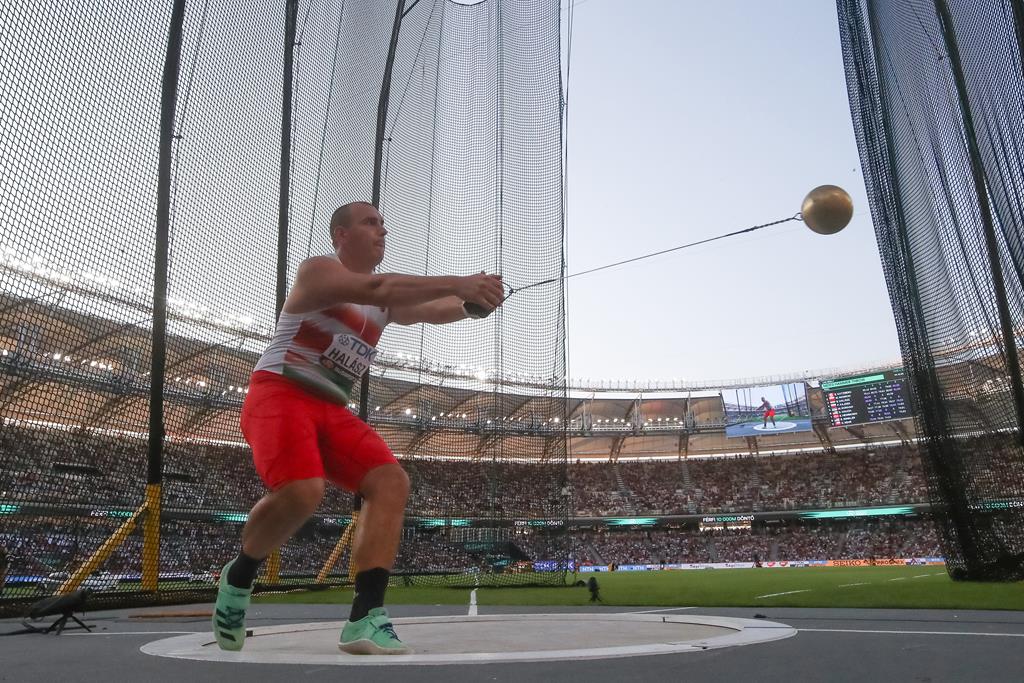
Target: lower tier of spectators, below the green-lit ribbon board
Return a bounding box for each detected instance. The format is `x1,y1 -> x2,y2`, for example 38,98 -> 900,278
0,517 -> 941,593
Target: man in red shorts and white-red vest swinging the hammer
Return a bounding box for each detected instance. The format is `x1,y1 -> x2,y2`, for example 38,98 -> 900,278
212,202 -> 504,654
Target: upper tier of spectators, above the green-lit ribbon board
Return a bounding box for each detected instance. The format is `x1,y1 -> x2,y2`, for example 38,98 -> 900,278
0,426 -> 937,517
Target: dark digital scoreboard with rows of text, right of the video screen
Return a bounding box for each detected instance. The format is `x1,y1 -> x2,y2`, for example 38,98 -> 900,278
821,368 -> 911,427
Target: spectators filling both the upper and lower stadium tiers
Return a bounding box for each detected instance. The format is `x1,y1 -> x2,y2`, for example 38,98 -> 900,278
0,425 -> 962,589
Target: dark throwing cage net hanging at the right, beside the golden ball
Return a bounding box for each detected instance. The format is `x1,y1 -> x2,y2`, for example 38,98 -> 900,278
839,0 -> 1024,581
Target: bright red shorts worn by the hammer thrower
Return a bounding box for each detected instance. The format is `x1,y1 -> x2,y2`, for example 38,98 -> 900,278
242,370 -> 398,493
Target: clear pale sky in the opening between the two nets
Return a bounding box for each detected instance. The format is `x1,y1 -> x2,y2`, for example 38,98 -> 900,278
563,0 -> 899,380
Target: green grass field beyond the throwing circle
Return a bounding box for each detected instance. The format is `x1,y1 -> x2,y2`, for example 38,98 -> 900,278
256,566 -> 1024,609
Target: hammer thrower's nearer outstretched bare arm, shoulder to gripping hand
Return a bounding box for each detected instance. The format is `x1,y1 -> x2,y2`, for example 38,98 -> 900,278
285,256 -> 505,313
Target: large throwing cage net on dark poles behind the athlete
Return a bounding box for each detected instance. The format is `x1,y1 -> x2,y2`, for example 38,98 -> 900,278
0,0 -> 570,613
